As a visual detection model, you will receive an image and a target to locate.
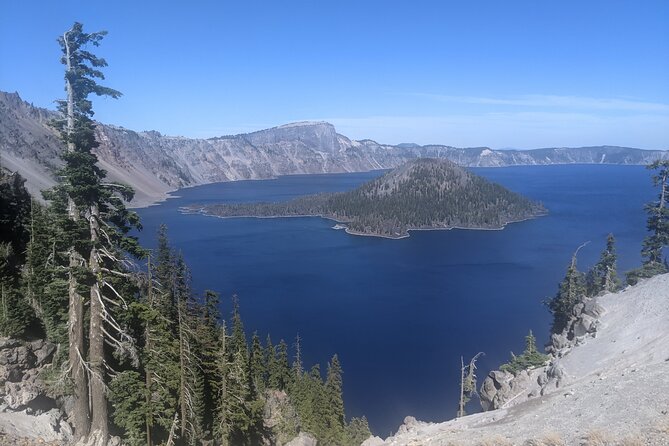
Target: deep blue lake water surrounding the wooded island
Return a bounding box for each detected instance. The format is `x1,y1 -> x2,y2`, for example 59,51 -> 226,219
134,165 -> 655,436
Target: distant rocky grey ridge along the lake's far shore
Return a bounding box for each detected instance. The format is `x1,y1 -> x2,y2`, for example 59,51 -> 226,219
0,92 -> 669,206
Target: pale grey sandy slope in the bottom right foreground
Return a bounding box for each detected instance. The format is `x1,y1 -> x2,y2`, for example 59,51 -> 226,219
364,274 -> 669,446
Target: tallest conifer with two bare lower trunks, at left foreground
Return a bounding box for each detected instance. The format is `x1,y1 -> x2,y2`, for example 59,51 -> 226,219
53,23 -> 141,441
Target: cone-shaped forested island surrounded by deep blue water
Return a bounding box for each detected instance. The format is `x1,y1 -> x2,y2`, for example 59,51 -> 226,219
182,158 -> 546,238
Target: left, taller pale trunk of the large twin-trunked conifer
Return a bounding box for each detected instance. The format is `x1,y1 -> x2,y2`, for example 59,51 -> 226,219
63,27 -> 91,440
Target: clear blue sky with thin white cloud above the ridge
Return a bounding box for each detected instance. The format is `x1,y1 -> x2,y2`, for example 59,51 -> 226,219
0,0 -> 669,149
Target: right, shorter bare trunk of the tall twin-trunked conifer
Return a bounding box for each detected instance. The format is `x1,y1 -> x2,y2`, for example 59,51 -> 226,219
89,204 -> 109,438
